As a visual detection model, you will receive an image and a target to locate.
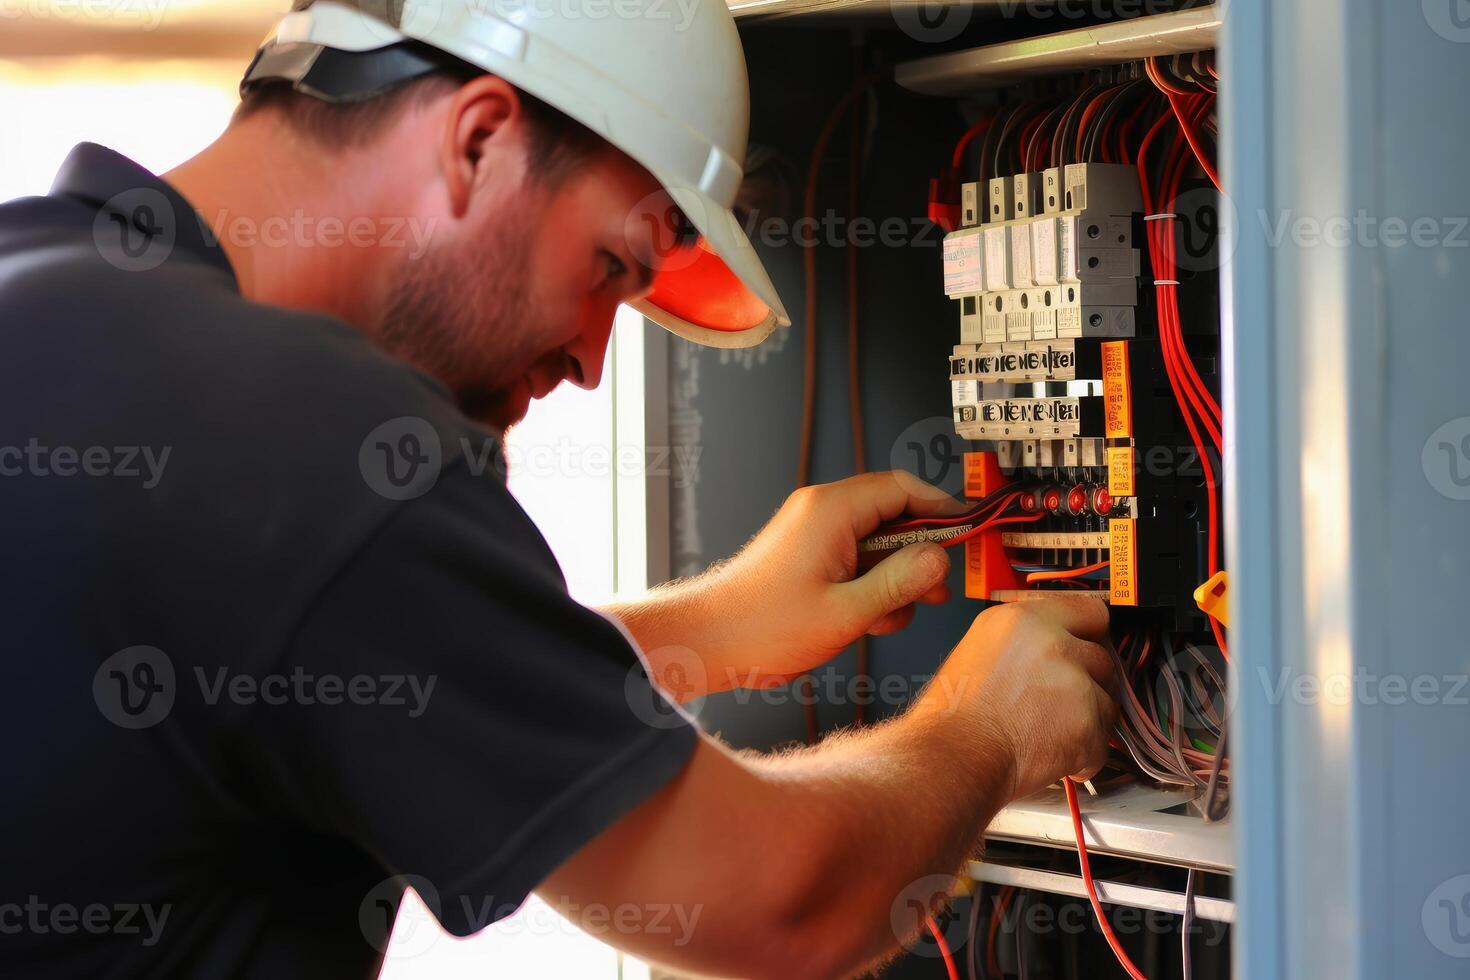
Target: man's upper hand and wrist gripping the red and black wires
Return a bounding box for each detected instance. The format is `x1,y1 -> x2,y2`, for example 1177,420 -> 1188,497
609,470 -> 964,696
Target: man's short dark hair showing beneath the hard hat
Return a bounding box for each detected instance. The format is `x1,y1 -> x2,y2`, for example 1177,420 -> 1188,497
231,65 -> 609,184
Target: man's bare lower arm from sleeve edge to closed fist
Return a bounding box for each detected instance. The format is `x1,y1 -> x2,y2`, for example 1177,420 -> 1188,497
539,590 -> 1117,977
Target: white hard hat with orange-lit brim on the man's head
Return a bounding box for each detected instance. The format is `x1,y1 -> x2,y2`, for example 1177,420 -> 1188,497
244,0 -> 791,347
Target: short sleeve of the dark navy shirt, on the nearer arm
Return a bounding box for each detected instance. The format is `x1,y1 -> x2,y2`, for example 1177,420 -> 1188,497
251,467 -> 698,936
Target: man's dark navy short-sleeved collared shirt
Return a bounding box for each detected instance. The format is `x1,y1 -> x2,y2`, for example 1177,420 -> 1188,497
0,144 -> 695,980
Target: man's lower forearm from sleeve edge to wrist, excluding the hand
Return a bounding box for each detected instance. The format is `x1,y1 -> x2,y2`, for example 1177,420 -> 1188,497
544,689 -> 1011,977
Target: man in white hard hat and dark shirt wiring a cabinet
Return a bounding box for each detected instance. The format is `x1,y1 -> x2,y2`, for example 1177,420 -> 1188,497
0,3 -> 1116,979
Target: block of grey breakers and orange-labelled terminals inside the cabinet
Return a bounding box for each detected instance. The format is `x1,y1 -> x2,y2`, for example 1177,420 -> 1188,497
942,163 -> 1219,630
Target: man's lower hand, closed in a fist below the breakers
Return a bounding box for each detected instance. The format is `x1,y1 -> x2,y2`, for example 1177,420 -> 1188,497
917,595 -> 1119,799
